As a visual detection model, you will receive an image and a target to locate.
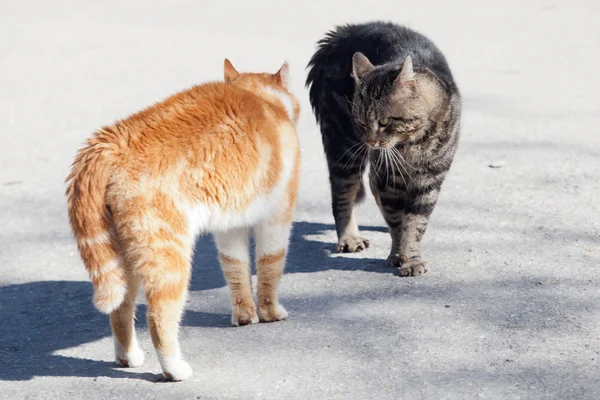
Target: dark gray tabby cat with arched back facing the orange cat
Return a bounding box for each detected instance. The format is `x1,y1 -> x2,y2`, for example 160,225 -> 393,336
307,22 -> 461,276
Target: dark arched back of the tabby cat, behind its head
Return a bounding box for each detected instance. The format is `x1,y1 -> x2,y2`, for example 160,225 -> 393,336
306,21 -> 456,118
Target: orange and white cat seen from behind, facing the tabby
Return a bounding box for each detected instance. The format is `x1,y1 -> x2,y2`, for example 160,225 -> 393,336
67,60 -> 300,380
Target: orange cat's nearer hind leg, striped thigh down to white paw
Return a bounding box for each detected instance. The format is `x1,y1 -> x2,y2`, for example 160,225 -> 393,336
121,205 -> 193,381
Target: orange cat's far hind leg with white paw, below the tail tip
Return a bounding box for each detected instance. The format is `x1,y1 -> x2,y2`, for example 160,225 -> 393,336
110,273 -> 144,368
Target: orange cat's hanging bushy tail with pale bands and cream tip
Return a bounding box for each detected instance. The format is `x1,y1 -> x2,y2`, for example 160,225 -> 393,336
66,128 -> 127,314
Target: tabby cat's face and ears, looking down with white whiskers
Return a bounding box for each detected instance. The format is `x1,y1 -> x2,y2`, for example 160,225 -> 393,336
352,53 -> 427,148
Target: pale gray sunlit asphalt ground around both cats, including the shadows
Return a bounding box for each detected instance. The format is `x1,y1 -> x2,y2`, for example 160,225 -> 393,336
0,0 -> 600,400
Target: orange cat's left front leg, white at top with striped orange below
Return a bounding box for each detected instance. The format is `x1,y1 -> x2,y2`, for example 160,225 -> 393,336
214,228 -> 258,326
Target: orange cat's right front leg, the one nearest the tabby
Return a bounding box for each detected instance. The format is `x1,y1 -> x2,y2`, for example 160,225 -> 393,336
254,220 -> 291,322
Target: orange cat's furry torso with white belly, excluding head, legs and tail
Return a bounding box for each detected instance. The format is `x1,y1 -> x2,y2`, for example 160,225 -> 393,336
100,78 -> 299,232
